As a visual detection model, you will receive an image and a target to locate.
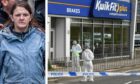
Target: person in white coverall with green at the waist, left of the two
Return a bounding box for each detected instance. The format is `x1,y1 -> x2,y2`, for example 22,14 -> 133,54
71,41 -> 82,72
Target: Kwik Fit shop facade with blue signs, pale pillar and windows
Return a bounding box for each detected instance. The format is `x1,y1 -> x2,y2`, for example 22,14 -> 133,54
48,0 -> 137,61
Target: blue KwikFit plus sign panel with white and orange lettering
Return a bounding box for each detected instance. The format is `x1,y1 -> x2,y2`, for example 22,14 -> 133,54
93,0 -> 131,20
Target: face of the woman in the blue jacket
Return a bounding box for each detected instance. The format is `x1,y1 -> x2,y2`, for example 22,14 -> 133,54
12,6 -> 32,32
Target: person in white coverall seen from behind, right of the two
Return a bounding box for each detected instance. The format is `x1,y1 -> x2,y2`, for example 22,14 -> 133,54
82,48 -> 94,81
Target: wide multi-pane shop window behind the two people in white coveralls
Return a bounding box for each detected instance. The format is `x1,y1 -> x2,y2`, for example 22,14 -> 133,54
70,18 -> 130,58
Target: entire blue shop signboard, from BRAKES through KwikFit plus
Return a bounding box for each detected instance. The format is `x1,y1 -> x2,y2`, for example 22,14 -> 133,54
48,0 -> 131,20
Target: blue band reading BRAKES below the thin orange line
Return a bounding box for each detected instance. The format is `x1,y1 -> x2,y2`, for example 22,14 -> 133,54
48,4 -> 90,17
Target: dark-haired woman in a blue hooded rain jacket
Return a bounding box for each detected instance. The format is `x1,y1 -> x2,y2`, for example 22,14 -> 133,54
0,1 -> 45,84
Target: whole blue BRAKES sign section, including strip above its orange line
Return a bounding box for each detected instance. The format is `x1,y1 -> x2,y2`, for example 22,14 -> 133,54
48,0 -> 94,17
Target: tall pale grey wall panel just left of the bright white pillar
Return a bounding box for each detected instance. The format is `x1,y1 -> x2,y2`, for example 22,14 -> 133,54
55,18 -> 65,61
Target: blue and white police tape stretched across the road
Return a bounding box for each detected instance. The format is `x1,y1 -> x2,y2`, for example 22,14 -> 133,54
48,72 -> 140,78
